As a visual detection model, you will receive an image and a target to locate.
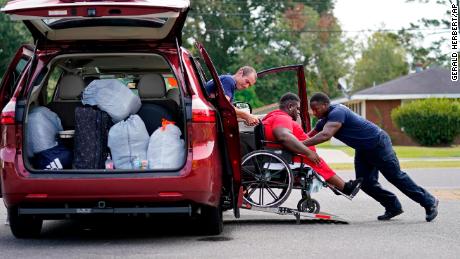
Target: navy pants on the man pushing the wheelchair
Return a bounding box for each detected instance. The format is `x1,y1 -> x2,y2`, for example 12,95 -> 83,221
355,131 -> 435,211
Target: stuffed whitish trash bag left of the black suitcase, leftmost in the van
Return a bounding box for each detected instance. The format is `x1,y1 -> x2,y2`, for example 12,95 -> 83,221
26,106 -> 63,157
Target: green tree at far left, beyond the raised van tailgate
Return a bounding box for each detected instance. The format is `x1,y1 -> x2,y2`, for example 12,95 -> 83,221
0,0 -> 32,79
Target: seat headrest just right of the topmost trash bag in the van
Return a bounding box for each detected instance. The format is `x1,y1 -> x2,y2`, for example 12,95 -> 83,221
137,74 -> 166,99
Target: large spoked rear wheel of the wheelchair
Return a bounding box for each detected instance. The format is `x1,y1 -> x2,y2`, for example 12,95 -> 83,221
241,150 -> 293,208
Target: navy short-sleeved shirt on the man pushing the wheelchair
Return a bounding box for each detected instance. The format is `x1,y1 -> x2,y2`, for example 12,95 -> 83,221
315,104 -> 382,149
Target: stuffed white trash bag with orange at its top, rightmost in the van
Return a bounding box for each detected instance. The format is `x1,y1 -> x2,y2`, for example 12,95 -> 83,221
147,119 -> 185,169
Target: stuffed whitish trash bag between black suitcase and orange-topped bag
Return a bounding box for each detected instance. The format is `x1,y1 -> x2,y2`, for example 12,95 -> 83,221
108,115 -> 149,169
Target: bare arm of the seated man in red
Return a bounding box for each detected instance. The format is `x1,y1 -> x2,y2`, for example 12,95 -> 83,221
273,127 -> 321,164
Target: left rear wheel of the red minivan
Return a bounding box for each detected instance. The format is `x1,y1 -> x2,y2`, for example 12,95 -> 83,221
8,207 -> 43,238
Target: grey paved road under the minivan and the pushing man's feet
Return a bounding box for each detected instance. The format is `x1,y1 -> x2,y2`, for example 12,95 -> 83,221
0,169 -> 460,258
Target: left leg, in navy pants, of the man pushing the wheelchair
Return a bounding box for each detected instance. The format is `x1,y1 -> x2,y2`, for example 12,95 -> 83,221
355,150 -> 402,212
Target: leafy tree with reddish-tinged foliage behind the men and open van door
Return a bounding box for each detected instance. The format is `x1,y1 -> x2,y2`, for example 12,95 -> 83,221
234,3 -> 351,104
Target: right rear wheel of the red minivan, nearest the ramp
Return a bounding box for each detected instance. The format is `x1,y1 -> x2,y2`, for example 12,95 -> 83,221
199,206 -> 224,236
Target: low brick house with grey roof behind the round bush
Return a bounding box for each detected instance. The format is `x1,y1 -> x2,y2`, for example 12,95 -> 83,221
332,68 -> 460,145
